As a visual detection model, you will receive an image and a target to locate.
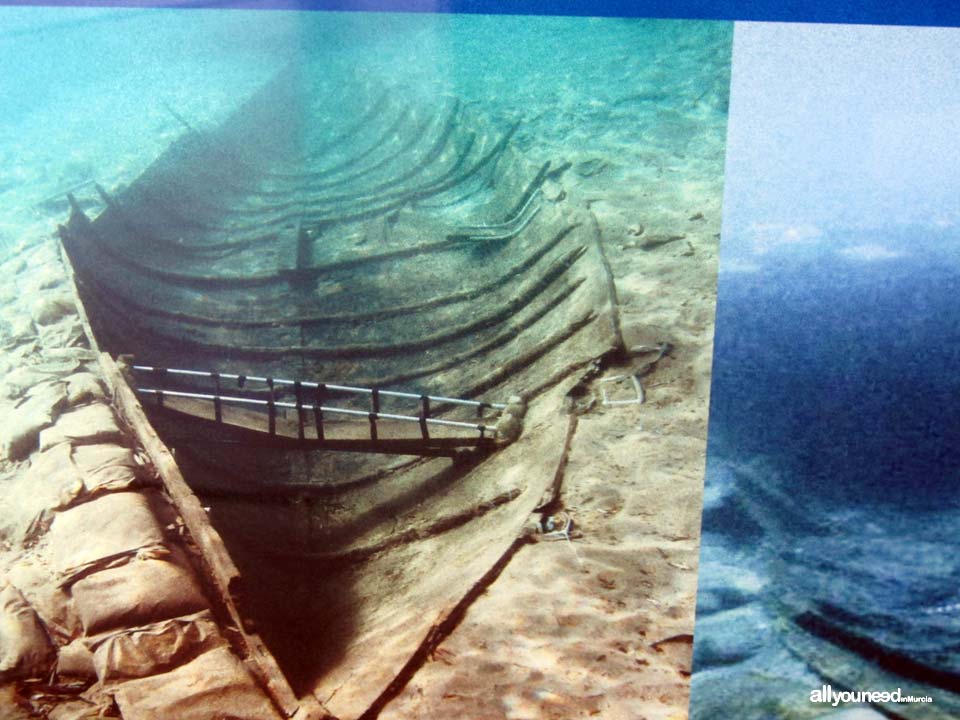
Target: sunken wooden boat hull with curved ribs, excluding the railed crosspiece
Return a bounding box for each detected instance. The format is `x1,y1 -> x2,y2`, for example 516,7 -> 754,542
61,70 -> 621,717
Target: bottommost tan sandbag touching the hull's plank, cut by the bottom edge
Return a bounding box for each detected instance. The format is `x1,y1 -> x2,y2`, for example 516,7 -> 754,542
113,647 -> 281,720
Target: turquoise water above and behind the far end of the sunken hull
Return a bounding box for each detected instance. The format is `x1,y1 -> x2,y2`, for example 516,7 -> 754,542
0,8 -> 731,256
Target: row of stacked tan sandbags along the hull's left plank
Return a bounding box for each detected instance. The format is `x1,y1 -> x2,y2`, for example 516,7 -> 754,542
0,380 -> 279,720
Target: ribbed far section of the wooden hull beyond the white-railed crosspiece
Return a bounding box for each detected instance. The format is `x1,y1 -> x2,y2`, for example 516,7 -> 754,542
62,67 -> 620,399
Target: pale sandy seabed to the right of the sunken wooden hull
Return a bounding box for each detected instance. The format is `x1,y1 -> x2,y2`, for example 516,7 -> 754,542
382,136 -> 720,719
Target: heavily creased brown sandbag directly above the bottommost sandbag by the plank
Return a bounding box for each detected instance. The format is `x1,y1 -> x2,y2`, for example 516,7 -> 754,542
85,611 -> 226,683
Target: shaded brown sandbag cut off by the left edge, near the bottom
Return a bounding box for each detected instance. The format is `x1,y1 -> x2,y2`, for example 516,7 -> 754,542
0,583 -> 53,680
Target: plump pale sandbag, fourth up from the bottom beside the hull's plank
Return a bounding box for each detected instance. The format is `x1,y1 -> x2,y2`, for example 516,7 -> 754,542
48,492 -> 163,584
